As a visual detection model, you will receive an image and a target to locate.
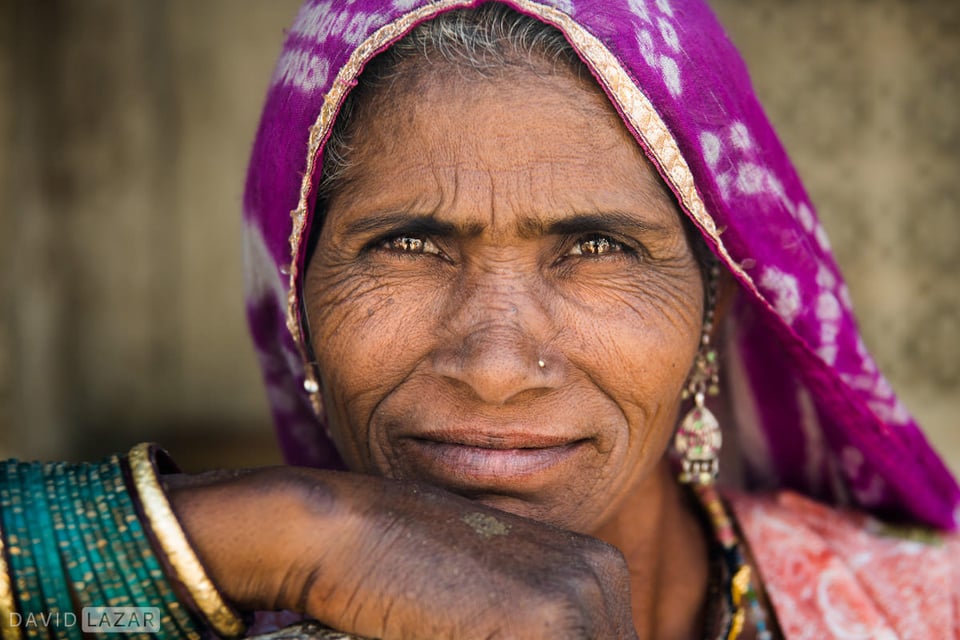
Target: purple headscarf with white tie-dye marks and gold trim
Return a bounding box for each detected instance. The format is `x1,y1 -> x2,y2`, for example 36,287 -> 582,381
244,0 -> 960,530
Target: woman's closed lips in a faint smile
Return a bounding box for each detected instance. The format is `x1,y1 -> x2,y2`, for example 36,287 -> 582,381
394,434 -> 588,493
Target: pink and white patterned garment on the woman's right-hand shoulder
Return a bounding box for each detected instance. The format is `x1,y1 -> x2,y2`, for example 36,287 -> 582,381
728,491 -> 960,640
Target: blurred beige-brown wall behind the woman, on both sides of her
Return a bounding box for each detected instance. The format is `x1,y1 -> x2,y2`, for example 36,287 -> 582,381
0,0 -> 960,472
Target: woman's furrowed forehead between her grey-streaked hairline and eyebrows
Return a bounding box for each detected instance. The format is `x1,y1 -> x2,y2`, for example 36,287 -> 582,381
326,68 -> 683,240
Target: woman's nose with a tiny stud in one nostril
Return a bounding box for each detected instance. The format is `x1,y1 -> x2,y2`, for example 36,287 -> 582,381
433,276 -> 563,406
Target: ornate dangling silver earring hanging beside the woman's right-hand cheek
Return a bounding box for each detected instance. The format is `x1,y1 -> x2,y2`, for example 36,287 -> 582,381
673,262 -> 723,485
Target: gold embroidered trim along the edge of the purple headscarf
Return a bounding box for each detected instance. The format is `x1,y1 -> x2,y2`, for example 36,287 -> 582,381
287,0 -> 760,392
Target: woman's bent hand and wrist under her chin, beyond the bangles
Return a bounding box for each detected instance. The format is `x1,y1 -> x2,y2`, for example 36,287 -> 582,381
165,467 -> 636,640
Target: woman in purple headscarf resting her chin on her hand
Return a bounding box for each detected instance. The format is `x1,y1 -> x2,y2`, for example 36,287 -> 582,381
0,0 -> 960,638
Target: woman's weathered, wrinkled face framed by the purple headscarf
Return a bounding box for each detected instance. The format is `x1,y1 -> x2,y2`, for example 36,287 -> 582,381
305,60 -> 703,532
